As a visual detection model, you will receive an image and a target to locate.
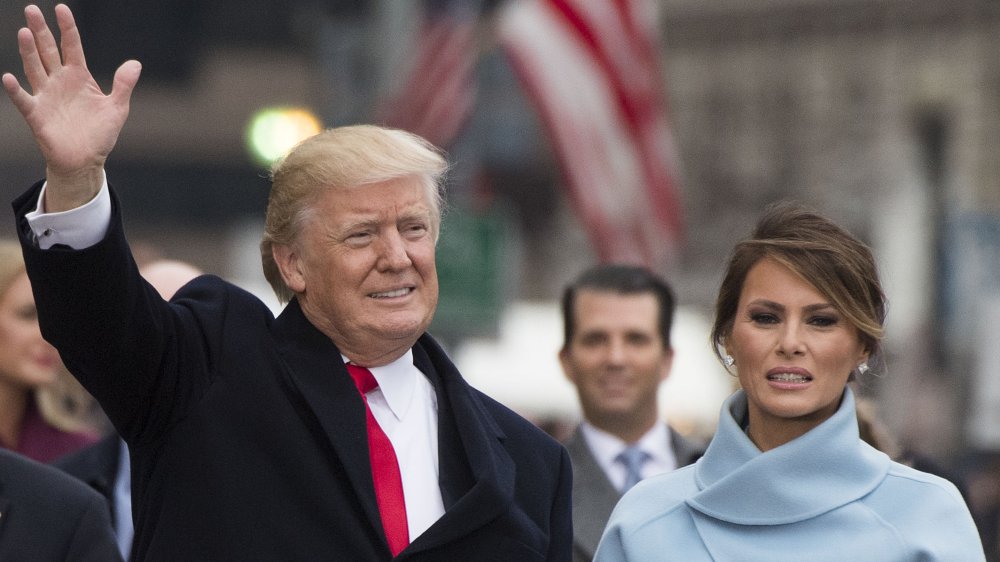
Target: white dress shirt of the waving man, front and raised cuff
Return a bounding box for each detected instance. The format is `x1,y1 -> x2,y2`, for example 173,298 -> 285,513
26,177 -> 444,542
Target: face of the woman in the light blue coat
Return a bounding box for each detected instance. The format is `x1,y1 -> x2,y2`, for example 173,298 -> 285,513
726,258 -> 868,446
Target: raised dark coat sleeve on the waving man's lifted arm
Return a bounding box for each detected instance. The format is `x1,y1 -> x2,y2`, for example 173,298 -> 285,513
14,183 -> 217,442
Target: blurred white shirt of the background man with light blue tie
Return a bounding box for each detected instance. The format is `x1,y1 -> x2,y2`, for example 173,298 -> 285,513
580,421 -> 677,490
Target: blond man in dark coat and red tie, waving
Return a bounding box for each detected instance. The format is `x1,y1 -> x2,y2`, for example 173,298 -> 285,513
3,5 -> 572,560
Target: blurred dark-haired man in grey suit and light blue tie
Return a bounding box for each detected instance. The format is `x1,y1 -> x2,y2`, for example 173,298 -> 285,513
559,265 -> 704,561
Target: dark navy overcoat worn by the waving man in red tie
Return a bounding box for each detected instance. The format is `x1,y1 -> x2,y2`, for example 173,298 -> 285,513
14,185 -> 572,561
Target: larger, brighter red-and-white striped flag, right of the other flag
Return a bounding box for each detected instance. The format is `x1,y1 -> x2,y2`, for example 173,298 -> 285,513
498,0 -> 684,271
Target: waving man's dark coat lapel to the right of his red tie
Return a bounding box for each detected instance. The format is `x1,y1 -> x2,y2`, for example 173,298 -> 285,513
406,334 -> 515,553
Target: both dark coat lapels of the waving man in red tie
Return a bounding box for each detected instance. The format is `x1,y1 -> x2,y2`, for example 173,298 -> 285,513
273,308 -> 515,554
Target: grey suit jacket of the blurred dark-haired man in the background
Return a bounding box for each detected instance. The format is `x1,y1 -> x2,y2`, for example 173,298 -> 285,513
566,427 -> 705,562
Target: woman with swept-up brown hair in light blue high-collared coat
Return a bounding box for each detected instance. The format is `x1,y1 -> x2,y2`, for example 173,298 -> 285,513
595,204 -> 985,562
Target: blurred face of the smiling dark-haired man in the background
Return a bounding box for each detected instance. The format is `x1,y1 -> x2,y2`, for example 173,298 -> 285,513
559,289 -> 673,429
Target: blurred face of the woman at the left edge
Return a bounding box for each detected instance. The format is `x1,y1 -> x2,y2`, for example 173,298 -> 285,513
0,273 -> 59,389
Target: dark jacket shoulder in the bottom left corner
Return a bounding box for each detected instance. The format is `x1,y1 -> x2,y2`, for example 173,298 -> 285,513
0,449 -> 121,562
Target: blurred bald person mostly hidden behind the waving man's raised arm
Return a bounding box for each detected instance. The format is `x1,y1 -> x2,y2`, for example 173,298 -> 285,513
53,259 -> 202,560
